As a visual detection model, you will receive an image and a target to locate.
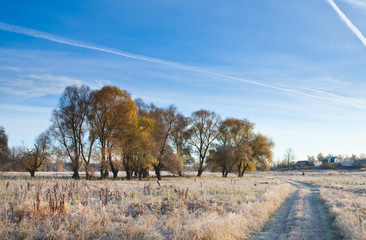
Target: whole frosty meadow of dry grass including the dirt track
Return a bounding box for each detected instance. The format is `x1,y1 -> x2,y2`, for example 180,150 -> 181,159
0,171 -> 366,239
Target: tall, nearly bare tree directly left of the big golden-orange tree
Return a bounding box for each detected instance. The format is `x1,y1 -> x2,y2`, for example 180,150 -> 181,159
51,85 -> 90,179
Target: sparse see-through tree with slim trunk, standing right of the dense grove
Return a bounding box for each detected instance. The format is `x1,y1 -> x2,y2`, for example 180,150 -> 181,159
189,110 -> 220,177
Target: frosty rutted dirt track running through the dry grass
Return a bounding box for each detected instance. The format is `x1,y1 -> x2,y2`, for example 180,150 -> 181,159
252,182 -> 342,240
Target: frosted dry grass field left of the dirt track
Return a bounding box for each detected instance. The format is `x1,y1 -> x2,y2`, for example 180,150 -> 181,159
0,176 -> 293,239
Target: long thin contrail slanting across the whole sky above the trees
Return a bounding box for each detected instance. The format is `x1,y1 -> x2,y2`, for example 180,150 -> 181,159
0,21 -> 366,109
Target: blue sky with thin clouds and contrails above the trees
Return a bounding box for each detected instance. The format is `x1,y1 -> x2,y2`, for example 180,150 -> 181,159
0,0 -> 366,160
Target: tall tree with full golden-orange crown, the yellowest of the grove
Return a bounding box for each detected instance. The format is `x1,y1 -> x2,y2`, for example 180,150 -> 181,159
89,86 -> 137,179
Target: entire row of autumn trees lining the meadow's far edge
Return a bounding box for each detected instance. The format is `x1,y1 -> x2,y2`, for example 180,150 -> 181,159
0,85 -> 274,180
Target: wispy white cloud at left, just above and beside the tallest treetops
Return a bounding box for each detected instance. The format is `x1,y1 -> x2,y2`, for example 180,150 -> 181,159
0,74 -> 109,97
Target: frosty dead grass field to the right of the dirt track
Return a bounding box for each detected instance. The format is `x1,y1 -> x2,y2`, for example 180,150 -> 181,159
289,171 -> 366,240
